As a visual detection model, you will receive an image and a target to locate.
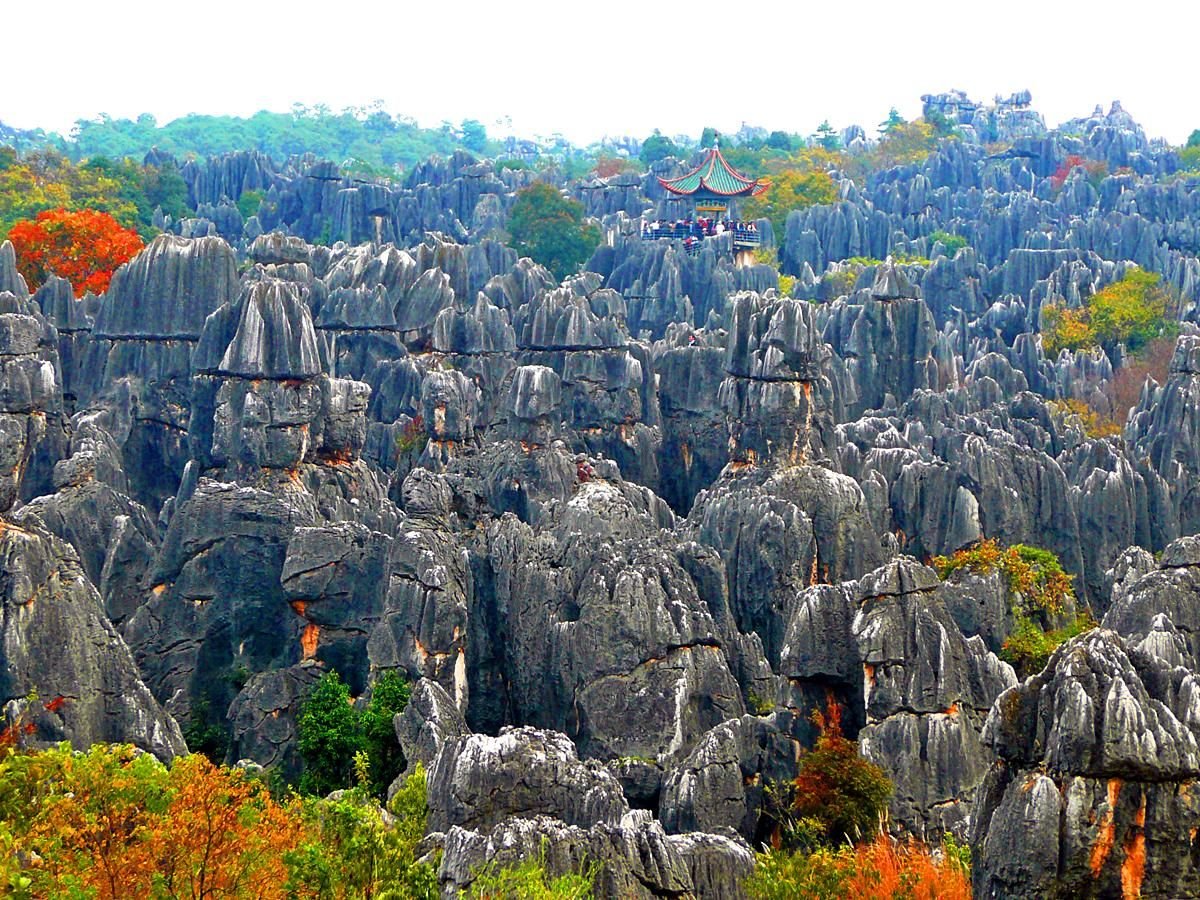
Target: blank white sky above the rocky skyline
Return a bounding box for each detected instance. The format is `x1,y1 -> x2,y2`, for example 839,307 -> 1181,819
0,0 -> 1200,143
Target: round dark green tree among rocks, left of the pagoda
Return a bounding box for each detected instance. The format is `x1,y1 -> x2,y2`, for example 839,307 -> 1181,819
509,181 -> 601,278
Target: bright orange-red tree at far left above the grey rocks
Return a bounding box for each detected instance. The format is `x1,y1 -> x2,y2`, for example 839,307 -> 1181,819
8,209 -> 144,296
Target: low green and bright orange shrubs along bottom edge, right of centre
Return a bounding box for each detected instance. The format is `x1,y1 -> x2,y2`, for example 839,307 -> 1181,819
745,834 -> 971,900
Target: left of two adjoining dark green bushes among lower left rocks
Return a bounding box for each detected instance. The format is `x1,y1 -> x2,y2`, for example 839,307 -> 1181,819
296,672 -> 362,796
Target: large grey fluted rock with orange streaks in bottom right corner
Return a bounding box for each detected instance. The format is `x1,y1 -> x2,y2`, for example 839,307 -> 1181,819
973,629 -> 1200,898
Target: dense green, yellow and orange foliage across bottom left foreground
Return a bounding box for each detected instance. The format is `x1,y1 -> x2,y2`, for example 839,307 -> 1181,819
0,736 -> 592,900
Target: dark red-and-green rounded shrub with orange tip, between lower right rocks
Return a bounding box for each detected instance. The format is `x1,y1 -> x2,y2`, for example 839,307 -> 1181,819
793,700 -> 892,844
